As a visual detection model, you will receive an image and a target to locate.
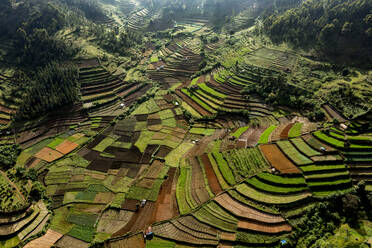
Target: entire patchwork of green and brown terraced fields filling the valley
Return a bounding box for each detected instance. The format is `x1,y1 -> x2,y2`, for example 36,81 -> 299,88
0,8 -> 372,248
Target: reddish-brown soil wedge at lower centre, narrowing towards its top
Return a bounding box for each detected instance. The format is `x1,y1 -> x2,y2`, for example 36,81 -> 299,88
152,168 -> 177,222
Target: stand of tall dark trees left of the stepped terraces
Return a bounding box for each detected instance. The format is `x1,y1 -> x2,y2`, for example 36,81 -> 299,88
16,62 -> 79,119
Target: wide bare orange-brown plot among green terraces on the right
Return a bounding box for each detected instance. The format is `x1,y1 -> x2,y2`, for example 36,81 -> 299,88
260,144 -> 301,174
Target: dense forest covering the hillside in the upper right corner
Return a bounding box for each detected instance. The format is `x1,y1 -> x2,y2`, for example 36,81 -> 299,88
264,0 -> 372,62
